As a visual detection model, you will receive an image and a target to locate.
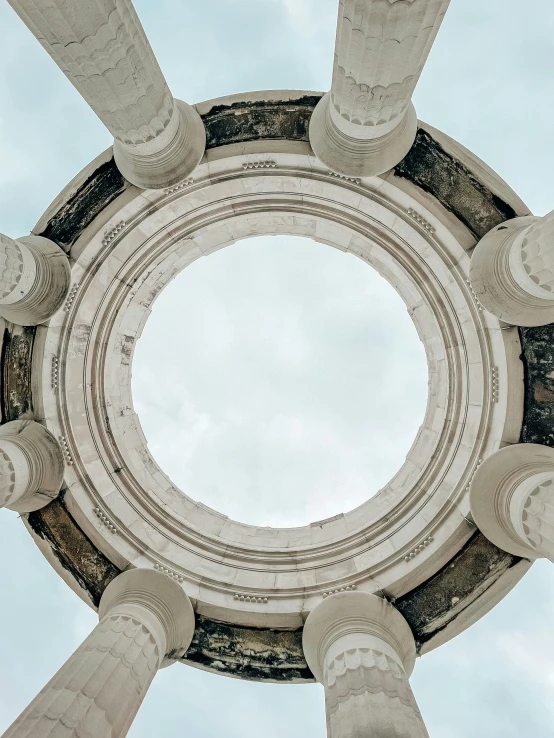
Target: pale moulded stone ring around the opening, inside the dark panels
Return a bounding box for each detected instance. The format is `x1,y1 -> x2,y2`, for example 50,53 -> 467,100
31,125 -> 523,627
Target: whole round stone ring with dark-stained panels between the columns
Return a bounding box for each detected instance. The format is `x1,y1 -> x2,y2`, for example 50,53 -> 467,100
3,91 -> 553,682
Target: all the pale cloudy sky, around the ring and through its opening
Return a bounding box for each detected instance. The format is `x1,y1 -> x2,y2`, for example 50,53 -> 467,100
0,0 -> 554,738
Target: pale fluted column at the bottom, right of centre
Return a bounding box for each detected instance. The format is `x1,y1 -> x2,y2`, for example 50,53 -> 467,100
302,592 -> 428,738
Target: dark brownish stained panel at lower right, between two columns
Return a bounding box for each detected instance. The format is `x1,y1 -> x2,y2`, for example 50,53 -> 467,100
394,531 -> 521,645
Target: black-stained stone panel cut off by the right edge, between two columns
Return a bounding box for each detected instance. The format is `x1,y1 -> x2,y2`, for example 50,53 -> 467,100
519,324 -> 554,447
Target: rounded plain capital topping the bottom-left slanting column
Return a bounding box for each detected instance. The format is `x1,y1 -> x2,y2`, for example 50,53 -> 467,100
98,569 -> 195,665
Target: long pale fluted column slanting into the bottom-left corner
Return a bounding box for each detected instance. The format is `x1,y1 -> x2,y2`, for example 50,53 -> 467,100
3,569 -> 194,738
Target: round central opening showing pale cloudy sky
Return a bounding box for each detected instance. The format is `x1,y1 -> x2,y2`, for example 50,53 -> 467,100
133,237 -> 427,527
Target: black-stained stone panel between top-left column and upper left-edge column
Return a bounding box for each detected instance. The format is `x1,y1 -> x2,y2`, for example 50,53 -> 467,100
39,158 -> 130,251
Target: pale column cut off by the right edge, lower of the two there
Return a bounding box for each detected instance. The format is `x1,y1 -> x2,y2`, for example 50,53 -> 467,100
470,443 -> 554,562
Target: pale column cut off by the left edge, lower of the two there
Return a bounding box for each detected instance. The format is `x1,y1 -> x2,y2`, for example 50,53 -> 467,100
0,420 -> 64,513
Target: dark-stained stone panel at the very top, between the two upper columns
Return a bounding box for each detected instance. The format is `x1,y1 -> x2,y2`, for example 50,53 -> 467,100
202,95 -> 320,149
